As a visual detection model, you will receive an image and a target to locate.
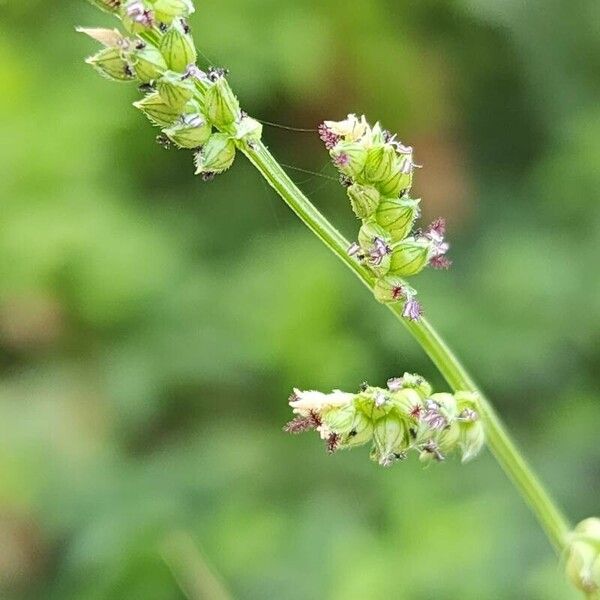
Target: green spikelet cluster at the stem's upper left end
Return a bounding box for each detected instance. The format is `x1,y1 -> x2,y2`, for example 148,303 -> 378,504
79,0 -> 262,180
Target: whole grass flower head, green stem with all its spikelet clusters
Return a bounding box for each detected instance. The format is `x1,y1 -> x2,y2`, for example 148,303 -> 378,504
79,0 -> 600,598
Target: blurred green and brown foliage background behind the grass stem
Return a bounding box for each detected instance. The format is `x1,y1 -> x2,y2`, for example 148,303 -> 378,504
0,0 -> 600,600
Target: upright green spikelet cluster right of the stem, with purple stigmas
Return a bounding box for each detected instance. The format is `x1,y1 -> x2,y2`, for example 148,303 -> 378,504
319,115 -> 450,320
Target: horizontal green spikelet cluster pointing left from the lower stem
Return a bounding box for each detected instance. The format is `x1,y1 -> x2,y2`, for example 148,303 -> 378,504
284,373 -> 485,467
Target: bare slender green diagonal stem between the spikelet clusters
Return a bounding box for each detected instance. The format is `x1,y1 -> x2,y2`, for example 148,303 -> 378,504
242,143 -> 570,553
